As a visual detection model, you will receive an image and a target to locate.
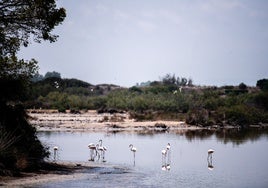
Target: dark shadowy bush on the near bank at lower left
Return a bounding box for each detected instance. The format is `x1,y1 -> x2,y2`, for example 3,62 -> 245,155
0,103 -> 48,175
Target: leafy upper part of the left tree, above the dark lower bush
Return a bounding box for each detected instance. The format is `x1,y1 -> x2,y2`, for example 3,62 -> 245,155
0,0 -> 66,102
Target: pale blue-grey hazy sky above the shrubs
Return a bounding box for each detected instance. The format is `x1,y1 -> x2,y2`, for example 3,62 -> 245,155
20,0 -> 268,86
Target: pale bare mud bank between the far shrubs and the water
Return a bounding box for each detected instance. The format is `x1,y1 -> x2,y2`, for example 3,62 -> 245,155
27,110 -> 200,131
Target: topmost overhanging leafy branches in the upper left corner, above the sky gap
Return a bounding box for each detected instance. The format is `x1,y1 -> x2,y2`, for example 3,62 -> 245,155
0,0 -> 66,56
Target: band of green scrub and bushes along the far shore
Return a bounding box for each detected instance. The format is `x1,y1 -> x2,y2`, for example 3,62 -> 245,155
25,74 -> 268,127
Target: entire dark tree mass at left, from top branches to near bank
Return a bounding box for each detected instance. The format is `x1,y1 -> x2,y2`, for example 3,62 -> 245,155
0,0 -> 66,175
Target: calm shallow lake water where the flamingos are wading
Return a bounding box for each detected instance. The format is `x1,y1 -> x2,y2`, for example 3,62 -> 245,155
38,130 -> 268,187
